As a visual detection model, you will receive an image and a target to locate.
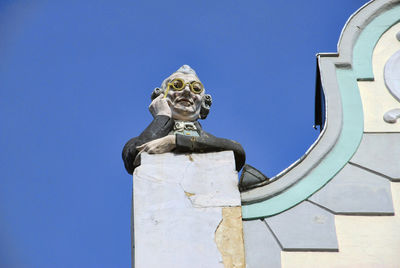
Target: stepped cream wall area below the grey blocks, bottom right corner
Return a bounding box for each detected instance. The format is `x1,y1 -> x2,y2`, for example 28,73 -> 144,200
281,182 -> 400,268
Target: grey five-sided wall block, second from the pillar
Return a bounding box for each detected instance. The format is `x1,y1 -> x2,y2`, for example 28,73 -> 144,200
265,201 -> 338,251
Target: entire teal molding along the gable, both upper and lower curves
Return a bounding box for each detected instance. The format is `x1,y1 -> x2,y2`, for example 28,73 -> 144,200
242,1 -> 400,220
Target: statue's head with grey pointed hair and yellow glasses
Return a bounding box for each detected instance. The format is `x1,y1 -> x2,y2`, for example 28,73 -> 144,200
151,65 -> 212,121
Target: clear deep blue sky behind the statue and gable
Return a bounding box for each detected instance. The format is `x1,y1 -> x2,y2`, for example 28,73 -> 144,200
0,0 -> 366,268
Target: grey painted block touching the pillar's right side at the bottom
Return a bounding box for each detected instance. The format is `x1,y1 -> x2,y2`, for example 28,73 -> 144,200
243,220 -> 281,268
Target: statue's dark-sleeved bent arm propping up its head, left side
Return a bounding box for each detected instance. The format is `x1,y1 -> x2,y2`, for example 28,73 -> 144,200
122,115 -> 173,174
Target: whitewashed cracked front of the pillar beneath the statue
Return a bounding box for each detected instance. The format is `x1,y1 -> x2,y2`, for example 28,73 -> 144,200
133,152 -> 240,268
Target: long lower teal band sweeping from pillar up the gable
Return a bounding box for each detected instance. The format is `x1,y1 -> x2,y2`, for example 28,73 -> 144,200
242,69 -> 364,220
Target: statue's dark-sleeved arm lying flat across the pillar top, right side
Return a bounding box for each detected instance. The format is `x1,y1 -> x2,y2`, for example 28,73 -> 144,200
176,132 -> 246,171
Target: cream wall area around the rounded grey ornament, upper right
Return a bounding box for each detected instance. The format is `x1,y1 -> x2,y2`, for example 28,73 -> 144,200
358,23 -> 400,132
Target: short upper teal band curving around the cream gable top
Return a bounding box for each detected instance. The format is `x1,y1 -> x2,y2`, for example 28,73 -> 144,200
353,6 -> 400,80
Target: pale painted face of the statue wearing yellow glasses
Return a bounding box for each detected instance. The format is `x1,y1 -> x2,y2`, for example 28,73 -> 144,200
167,73 -> 204,121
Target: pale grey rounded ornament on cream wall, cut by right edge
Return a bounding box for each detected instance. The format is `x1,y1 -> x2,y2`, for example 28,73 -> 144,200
383,50 -> 400,101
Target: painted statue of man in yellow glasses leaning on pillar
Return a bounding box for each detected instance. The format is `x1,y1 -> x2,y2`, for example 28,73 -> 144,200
122,65 -> 245,174
